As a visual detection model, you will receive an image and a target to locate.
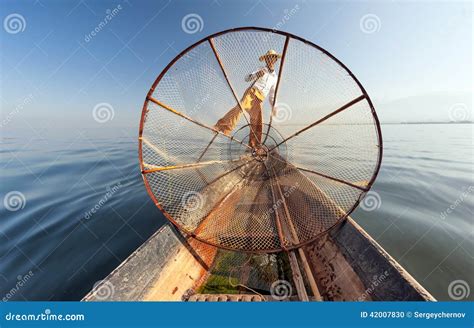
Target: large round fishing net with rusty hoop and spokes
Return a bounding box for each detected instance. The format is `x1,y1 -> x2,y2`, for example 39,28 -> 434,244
140,28 -> 382,254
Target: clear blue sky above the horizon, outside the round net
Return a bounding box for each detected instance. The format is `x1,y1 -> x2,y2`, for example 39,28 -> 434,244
0,0 -> 473,129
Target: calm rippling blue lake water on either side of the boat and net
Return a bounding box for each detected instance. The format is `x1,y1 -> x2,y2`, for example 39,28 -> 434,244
0,124 -> 474,300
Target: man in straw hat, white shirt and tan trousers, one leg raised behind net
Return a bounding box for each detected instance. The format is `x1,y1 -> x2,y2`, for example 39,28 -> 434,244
214,49 -> 281,149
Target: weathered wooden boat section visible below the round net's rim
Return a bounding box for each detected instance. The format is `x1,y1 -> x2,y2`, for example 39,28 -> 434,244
83,164 -> 435,301
